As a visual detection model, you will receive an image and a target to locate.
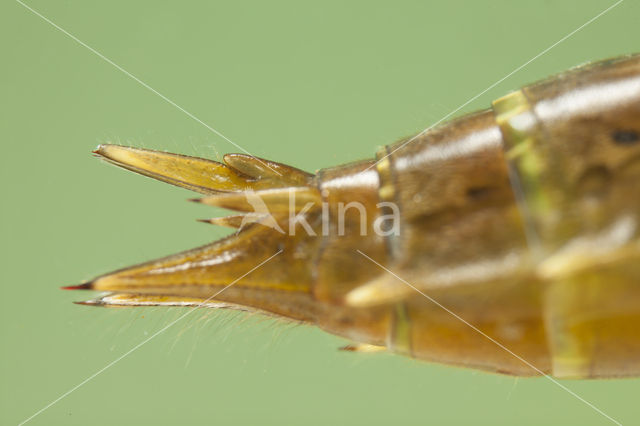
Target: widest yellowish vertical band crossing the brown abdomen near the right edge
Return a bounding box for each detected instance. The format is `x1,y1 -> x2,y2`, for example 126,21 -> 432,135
493,90 -> 593,378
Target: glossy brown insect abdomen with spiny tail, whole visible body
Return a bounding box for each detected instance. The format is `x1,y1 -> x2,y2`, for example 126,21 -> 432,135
66,55 -> 640,378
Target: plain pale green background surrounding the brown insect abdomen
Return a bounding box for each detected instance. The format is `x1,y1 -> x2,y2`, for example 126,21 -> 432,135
0,0 -> 640,425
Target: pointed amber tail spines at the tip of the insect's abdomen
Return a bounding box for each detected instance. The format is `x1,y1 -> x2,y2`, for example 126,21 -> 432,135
72,145 -> 321,322
